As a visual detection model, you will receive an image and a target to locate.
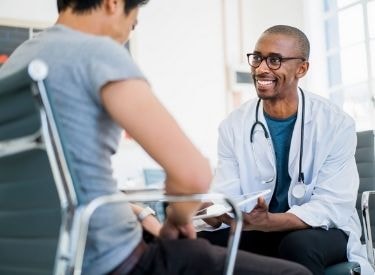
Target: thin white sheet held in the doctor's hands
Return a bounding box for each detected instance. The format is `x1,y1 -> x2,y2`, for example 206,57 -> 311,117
192,189 -> 271,220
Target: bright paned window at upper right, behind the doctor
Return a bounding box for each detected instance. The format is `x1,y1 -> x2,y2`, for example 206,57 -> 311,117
323,0 -> 375,130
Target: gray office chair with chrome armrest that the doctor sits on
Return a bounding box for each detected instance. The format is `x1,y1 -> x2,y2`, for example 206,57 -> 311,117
325,130 -> 375,275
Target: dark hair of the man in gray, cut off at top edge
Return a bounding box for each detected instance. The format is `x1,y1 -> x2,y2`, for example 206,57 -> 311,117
57,0 -> 148,14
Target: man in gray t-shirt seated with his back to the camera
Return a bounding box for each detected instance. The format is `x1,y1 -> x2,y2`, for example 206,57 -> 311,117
0,0 -> 310,275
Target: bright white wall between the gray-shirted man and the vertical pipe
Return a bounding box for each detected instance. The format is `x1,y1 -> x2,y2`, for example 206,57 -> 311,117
134,0 -> 225,164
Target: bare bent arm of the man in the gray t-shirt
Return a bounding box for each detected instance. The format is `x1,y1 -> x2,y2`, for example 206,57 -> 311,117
101,79 -> 211,237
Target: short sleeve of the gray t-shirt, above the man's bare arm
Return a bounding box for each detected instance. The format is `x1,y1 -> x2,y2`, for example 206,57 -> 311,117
83,38 -> 146,105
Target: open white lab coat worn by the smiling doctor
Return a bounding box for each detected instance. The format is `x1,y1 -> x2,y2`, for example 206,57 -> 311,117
213,92 -> 374,275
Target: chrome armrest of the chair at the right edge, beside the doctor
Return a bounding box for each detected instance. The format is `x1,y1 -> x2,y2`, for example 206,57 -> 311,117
361,191 -> 375,267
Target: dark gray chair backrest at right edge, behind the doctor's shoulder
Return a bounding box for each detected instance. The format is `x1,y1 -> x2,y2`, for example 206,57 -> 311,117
355,130 -> 375,246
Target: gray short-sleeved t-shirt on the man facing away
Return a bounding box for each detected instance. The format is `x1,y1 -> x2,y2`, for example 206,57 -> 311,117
0,25 -> 144,275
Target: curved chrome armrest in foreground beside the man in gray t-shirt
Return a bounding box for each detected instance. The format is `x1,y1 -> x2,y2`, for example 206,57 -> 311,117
72,191 -> 243,275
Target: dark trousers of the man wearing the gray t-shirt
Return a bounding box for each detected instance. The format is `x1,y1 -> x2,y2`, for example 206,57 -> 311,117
123,239 -> 311,275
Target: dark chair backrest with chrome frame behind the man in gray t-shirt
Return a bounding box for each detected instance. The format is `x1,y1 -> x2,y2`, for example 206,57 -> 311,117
0,60 -> 76,275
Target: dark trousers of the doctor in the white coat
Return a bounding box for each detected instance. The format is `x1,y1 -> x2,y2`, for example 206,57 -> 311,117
198,228 -> 348,275
